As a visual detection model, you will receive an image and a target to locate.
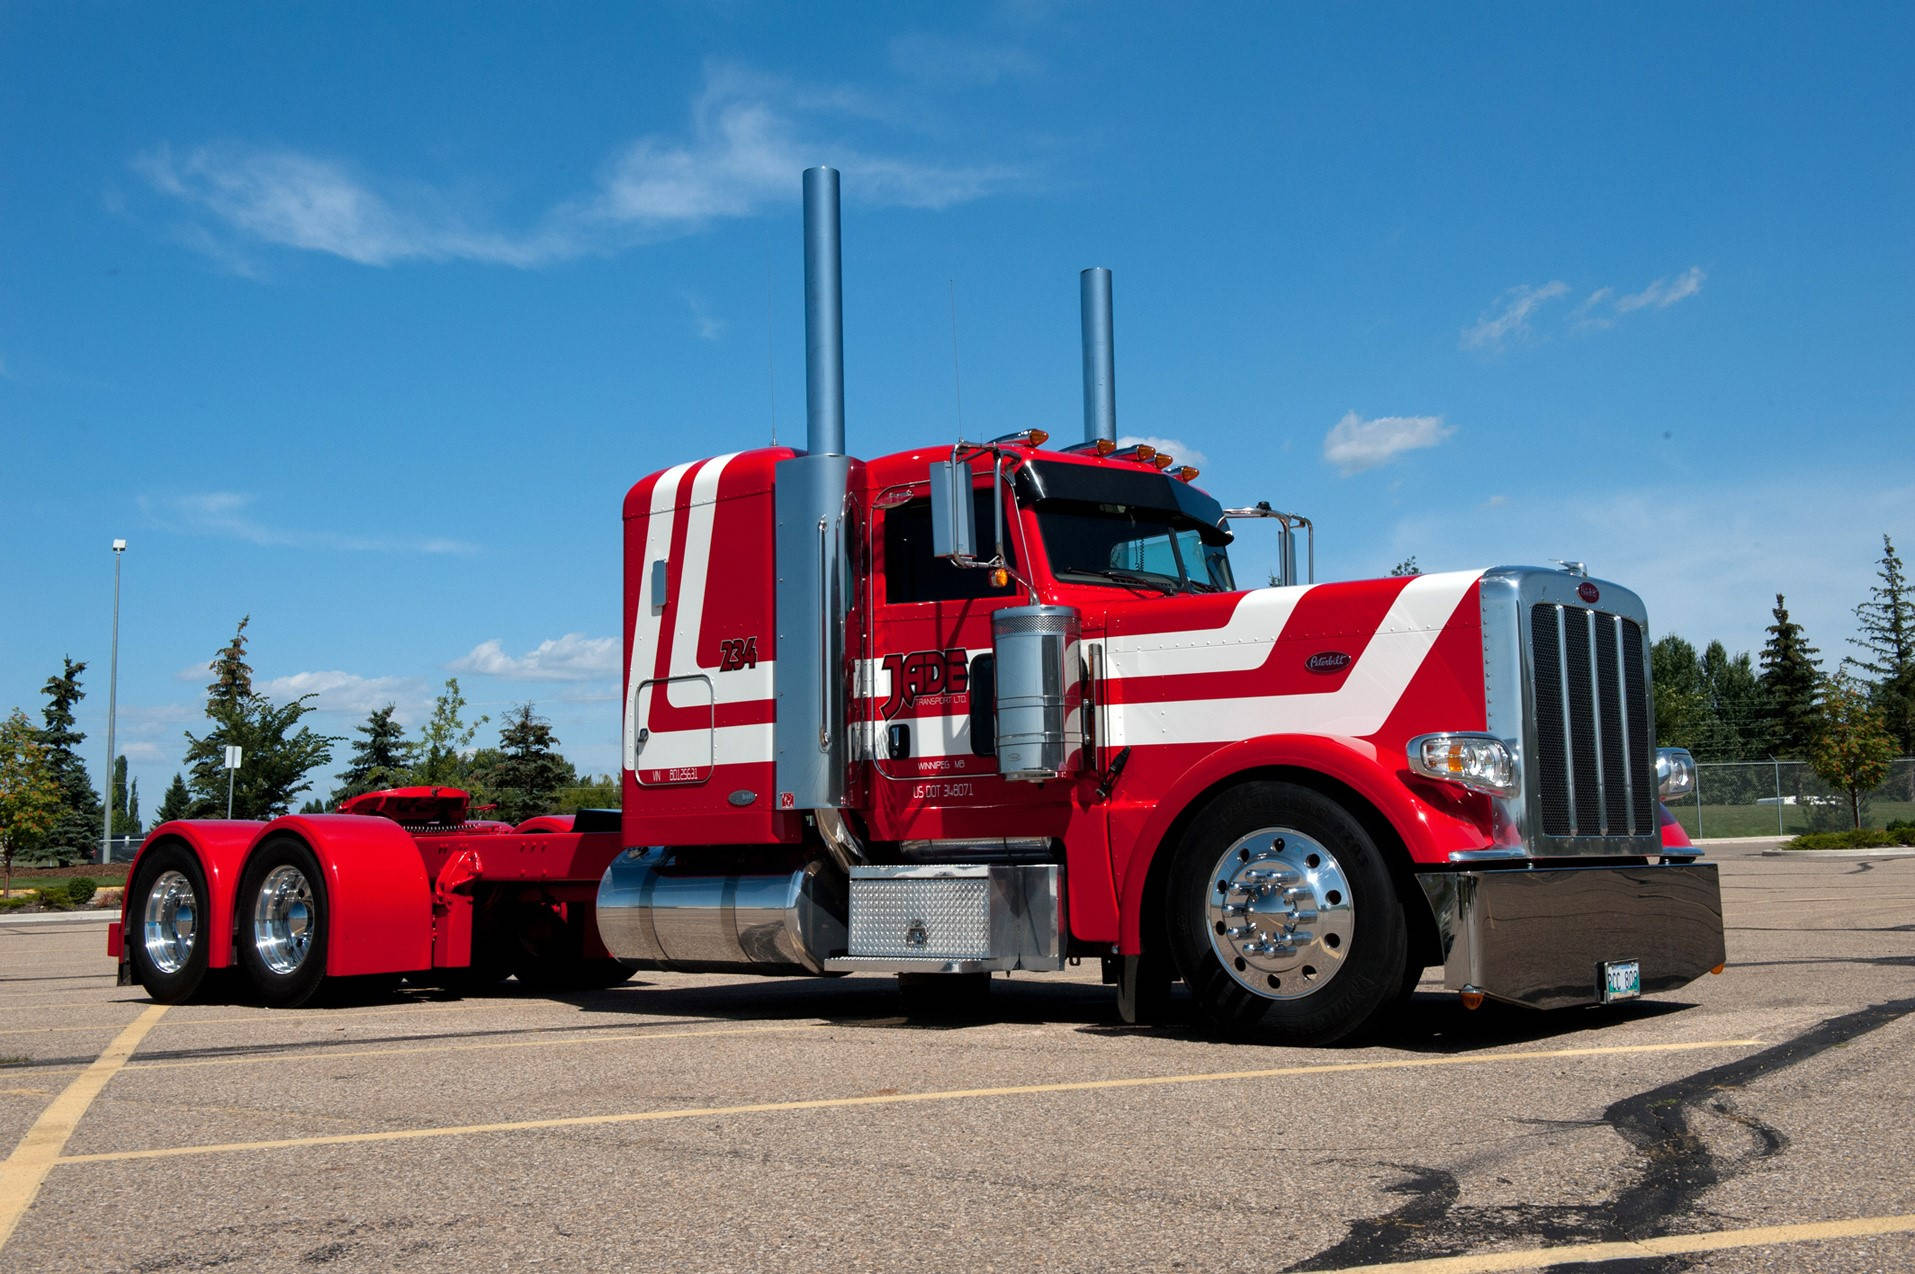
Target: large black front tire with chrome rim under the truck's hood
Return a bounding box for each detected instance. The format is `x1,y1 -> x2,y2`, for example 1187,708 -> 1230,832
1168,782 -> 1409,1044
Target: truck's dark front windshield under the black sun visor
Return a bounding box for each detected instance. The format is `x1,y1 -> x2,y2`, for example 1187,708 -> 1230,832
1038,504 -> 1237,592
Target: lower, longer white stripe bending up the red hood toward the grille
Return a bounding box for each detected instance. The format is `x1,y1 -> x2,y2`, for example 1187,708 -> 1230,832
1111,571 -> 1480,747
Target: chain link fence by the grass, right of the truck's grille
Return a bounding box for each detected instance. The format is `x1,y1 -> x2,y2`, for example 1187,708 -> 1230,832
1670,757 -> 1915,841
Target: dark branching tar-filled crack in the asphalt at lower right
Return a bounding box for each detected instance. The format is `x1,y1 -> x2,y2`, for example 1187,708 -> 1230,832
1287,998 -> 1915,1274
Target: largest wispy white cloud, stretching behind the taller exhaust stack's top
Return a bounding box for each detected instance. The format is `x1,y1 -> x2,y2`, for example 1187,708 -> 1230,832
134,65 -> 1019,274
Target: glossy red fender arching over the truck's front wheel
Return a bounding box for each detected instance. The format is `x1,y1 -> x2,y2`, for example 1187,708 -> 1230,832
1118,734 -> 1490,954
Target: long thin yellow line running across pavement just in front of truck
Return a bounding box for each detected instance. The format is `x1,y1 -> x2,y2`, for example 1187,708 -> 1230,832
59,1040 -> 1762,1163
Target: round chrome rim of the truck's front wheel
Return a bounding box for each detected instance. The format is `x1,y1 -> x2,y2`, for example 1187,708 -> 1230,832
1208,828 -> 1356,1000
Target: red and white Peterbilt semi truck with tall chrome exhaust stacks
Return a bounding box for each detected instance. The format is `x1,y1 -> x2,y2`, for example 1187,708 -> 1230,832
109,169 -> 1724,1044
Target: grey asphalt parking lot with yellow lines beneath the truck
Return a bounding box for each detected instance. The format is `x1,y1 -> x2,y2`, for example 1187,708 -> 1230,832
0,847 -> 1915,1274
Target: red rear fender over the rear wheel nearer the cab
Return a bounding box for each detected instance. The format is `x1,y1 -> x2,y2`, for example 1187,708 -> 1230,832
257,814 -> 433,977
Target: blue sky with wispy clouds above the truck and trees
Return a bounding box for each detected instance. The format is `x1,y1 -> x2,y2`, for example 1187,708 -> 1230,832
0,0 -> 1915,810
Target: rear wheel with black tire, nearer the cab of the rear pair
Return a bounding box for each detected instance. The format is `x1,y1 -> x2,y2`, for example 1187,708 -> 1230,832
236,835 -> 331,1008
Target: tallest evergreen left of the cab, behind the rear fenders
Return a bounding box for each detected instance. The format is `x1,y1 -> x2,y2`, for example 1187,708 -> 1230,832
186,619 -> 339,818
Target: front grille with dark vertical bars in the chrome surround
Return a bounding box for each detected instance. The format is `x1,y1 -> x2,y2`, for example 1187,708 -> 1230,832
1530,602 -> 1656,837
